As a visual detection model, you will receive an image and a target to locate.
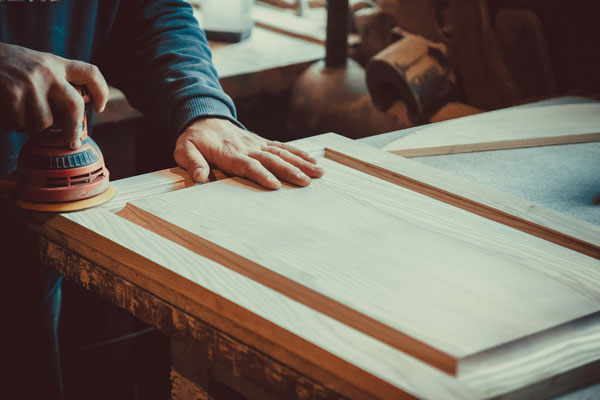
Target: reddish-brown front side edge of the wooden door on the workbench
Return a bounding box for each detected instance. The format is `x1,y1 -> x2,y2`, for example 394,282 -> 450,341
30,208 -> 408,399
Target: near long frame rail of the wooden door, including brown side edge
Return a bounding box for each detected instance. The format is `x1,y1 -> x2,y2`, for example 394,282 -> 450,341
32,208 -> 450,399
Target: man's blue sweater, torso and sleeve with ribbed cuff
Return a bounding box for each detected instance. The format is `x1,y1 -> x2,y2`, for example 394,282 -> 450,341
0,0 -> 235,174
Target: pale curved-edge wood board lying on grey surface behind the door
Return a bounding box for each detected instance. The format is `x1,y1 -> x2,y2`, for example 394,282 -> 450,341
384,103 -> 600,157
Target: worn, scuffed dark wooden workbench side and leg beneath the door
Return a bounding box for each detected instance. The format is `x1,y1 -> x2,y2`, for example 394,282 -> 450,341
39,238 -> 346,400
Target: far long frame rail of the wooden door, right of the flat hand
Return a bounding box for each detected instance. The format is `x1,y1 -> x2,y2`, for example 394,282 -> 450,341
302,134 -> 600,259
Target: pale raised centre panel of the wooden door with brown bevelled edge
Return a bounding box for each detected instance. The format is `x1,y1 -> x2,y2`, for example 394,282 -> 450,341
121,151 -> 600,373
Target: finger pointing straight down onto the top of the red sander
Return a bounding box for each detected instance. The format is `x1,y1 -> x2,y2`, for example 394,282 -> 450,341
50,82 -> 85,149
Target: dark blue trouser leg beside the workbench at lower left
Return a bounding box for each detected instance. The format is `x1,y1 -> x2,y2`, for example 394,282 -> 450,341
0,198 -> 63,399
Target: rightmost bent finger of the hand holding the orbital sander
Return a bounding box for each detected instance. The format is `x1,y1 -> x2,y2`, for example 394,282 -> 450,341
65,60 -> 108,112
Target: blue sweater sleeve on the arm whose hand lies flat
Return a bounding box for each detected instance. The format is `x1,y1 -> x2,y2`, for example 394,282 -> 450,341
98,0 -> 241,137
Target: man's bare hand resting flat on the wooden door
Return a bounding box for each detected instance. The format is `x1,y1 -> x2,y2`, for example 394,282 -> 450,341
174,118 -> 323,189
